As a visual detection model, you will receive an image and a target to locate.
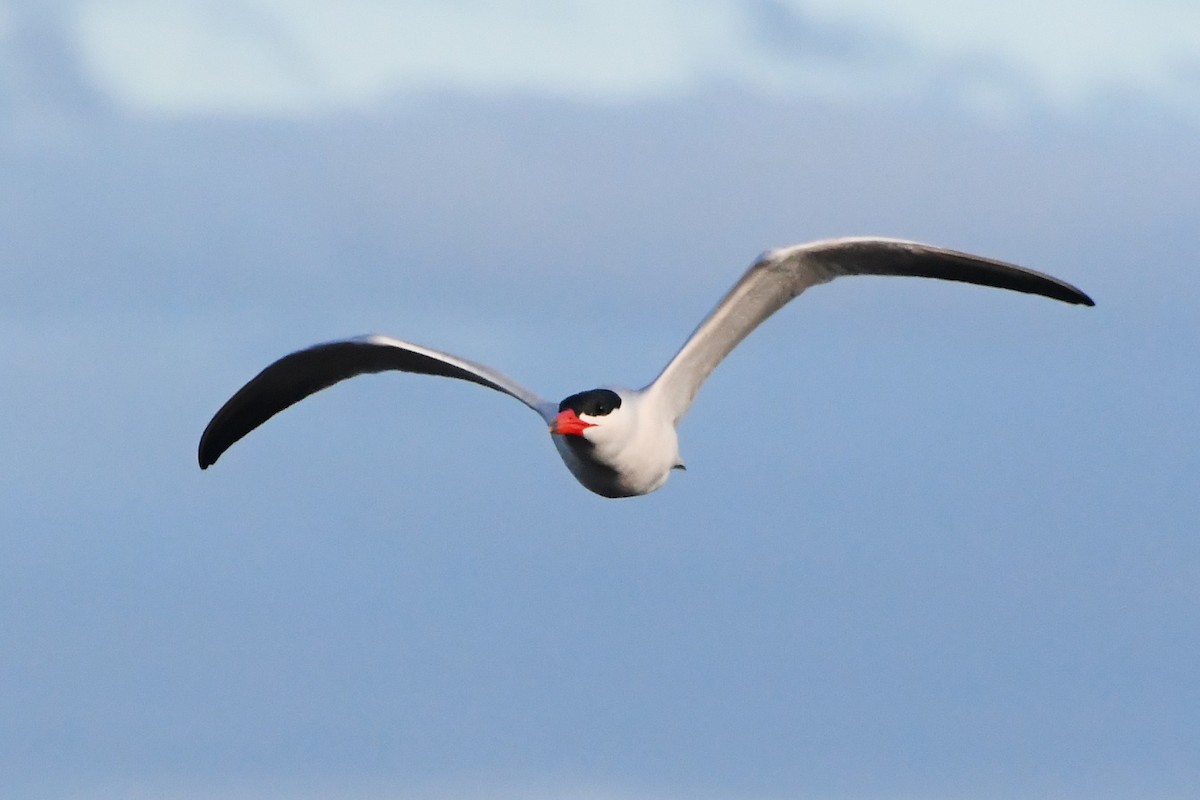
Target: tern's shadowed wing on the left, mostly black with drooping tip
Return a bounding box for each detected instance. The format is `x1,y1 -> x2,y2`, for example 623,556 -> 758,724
198,335 -> 558,469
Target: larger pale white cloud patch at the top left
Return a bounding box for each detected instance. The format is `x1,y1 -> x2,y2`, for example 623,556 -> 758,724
68,0 -> 740,113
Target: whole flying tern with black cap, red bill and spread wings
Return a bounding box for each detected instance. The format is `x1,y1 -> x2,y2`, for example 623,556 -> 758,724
199,237 -> 1094,498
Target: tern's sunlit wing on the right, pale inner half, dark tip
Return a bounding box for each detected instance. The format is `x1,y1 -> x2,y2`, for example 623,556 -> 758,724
647,237 -> 1094,422
